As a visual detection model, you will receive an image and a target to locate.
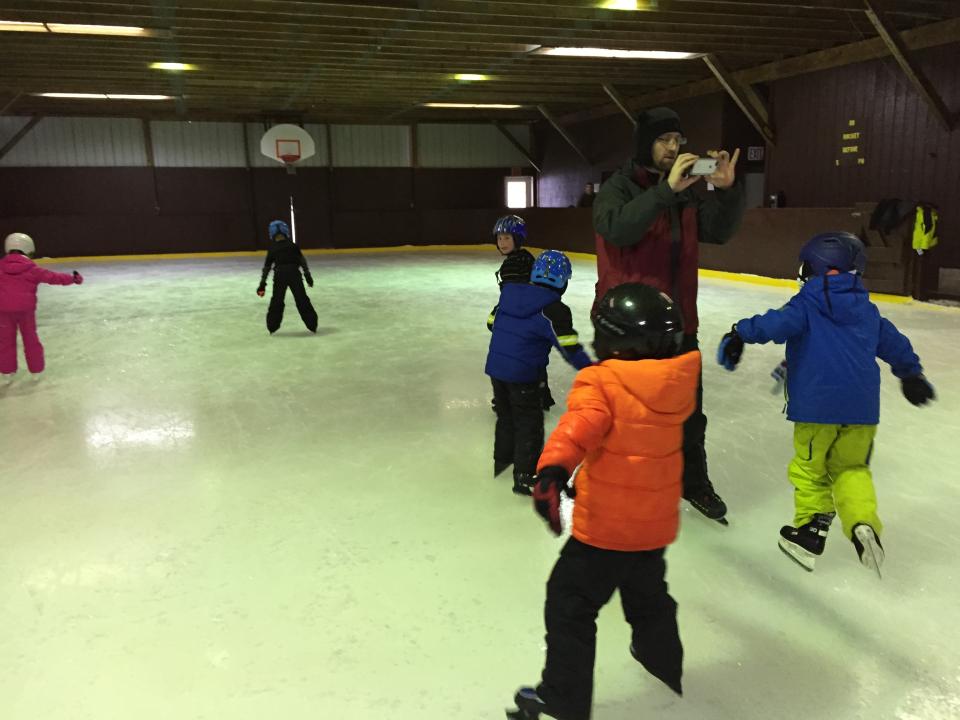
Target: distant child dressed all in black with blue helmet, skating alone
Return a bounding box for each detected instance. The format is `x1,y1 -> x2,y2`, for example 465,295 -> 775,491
257,220 -> 317,335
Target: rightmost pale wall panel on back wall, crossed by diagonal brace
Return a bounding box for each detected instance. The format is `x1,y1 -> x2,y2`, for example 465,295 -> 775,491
417,124 -> 530,168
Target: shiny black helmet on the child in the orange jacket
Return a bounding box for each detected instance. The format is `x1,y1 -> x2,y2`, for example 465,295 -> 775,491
592,283 -> 683,360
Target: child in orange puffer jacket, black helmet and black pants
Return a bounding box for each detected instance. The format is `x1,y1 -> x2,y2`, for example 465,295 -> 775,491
507,283 -> 700,720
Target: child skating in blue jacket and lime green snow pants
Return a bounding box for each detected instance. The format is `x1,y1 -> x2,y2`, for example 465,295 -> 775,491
717,232 -> 934,574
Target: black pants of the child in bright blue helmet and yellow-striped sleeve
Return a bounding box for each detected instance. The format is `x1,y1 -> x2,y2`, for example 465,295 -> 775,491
490,378 -> 543,477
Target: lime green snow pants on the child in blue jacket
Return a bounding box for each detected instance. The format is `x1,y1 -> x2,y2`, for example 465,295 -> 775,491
787,422 -> 883,538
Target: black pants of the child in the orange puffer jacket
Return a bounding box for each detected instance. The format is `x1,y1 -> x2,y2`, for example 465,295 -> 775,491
537,538 -> 683,720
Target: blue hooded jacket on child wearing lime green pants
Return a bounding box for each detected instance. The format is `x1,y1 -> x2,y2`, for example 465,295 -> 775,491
736,273 -> 923,425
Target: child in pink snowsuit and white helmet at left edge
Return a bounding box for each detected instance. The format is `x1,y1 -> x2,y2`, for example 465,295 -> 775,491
0,233 -> 83,375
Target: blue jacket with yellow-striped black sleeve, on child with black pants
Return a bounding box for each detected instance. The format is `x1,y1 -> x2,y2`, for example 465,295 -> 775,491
485,283 -> 593,383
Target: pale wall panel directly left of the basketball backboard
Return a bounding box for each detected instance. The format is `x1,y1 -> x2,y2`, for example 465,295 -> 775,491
150,120 -> 246,167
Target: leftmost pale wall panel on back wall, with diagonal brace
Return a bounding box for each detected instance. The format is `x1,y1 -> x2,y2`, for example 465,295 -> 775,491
0,117 -> 147,167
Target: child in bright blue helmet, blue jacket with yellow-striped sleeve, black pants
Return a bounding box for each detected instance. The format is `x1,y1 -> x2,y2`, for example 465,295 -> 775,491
485,250 -> 591,495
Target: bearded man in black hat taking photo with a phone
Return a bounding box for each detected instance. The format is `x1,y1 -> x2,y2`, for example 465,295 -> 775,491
593,107 -> 745,524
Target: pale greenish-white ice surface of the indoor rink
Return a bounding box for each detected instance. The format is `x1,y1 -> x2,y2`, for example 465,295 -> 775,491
0,248 -> 960,720
